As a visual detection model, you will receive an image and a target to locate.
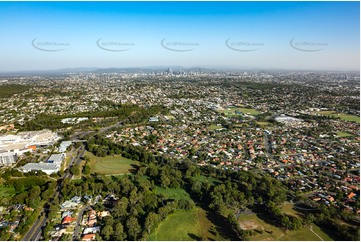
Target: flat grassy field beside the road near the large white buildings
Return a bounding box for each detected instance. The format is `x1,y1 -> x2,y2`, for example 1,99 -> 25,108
85,152 -> 139,175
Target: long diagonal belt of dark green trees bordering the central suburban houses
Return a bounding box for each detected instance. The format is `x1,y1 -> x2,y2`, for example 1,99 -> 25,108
81,135 -> 310,239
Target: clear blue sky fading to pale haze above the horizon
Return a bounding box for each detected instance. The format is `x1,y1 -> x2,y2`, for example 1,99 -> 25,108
0,2 -> 360,72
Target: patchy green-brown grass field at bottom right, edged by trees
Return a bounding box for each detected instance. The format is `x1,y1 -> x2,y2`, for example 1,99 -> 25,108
238,212 -> 332,241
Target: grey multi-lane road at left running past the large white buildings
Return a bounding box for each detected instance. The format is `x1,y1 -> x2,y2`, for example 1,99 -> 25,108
22,145 -> 85,241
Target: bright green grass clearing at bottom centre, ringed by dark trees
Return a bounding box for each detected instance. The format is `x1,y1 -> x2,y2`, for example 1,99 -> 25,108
149,208 -> 224,241
